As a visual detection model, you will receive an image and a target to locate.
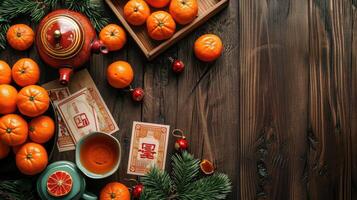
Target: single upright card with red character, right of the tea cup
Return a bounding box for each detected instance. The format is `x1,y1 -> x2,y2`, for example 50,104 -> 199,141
128,122 -> 170,176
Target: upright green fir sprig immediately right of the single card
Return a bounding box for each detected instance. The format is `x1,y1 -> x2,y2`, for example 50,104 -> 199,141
172,151 -> 199,195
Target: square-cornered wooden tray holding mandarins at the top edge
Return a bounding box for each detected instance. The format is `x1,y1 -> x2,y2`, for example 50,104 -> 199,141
105,0 -> 229,60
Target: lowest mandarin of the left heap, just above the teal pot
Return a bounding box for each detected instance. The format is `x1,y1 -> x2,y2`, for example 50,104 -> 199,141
16,142 -> 48,175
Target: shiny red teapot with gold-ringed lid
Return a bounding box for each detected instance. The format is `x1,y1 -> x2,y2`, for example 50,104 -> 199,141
36,9 -> 108,84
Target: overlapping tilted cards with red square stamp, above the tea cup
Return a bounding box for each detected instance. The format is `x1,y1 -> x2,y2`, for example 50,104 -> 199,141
43,69 -> 119,152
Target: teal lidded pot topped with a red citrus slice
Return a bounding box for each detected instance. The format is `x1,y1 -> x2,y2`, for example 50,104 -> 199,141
36,161 -> 98,200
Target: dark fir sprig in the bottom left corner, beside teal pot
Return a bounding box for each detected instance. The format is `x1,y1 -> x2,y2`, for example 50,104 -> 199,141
0,179 -> 37,200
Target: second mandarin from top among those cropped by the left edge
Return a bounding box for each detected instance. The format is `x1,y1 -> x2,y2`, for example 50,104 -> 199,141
0,84 -> 17,114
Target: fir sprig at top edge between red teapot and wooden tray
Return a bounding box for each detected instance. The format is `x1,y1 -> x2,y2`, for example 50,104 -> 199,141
64,0 -> 109,31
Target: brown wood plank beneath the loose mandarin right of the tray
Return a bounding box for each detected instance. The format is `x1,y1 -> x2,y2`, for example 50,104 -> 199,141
143,1 -> 239,199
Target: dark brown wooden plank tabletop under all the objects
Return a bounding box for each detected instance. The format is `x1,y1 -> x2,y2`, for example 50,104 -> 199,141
0,0 -> 357,200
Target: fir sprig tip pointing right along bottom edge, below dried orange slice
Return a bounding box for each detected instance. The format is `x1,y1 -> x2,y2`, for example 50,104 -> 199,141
178,173 -> 232,200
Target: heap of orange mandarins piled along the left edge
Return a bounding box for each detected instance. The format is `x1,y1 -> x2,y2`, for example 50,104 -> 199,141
0,58 -> 55,175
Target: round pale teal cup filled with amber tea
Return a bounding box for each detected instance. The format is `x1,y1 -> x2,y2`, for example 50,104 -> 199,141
76,132 -> 121,179
